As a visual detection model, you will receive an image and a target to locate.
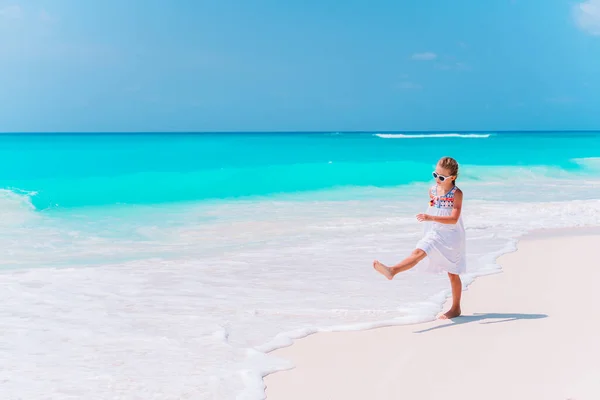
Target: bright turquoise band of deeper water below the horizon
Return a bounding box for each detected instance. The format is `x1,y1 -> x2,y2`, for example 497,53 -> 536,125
0,132 -> 600,209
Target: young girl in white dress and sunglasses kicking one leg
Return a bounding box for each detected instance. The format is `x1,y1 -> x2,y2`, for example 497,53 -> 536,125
373,157 -> 466,319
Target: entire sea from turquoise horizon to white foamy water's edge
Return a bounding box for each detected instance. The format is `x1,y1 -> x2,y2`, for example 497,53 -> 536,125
0,132 -> 600,400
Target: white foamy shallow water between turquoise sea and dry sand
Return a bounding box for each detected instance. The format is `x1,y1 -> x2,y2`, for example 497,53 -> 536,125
0,174 -> 600,400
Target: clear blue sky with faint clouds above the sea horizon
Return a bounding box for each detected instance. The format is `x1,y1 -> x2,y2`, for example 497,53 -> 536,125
0,0 -> 600,132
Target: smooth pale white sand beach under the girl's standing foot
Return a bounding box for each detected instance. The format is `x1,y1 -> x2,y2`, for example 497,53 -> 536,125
265,233 -> 600,400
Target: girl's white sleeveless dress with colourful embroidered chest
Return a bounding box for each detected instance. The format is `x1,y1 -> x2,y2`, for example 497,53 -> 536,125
416,185 -> 466,275
